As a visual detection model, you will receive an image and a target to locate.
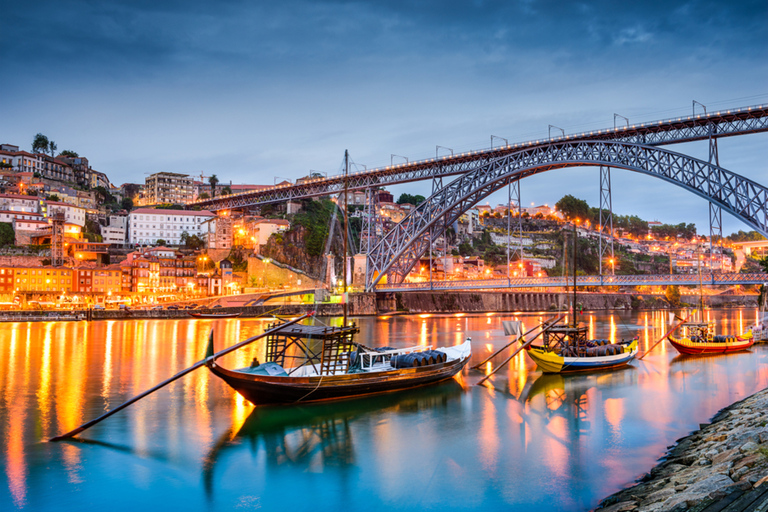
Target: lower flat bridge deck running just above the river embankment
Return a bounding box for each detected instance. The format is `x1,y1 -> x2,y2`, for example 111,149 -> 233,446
373,274 -> 766,292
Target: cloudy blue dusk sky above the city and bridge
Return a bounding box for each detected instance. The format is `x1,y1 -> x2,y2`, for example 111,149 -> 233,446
0,0 -> 768,233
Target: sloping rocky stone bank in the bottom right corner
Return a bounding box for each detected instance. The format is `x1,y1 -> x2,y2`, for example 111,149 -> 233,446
596,389 -> 768,512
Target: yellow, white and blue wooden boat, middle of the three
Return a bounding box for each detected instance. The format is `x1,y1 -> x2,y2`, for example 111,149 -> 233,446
526,325 -> 638,373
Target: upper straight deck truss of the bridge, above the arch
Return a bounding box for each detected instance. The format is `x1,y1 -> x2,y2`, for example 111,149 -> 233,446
187,105 -> 768,210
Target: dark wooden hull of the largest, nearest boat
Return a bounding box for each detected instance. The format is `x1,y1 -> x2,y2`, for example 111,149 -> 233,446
208,356 -> 469,405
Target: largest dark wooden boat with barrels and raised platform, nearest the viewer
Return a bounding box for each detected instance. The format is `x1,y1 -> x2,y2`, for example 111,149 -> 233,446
206,324 -> 471,405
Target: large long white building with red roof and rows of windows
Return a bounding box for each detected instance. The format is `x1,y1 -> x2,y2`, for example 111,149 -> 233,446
127,208 -> 215,245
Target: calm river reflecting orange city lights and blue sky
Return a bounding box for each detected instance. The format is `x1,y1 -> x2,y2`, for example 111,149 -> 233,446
0,309 -> 768,511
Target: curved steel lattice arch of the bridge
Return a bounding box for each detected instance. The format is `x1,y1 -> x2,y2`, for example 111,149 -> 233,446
366,140 -> 768,291
